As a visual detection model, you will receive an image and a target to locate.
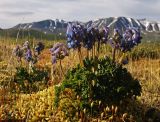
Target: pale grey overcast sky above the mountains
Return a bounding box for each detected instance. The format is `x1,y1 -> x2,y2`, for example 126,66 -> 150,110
0,0 -> 160,28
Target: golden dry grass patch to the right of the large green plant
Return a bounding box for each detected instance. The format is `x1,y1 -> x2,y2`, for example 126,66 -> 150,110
127,59 -> 160,109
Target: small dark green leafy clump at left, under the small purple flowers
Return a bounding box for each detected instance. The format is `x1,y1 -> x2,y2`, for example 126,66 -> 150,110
13,67 -> 48,93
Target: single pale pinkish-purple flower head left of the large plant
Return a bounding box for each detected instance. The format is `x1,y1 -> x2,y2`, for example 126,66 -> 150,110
50,42 -> 68,64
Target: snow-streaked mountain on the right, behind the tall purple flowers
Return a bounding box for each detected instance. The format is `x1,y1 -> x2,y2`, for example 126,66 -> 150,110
89,17 -> 160,32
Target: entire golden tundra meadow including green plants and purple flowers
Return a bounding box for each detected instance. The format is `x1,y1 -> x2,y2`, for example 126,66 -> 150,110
0,23 -> 160,122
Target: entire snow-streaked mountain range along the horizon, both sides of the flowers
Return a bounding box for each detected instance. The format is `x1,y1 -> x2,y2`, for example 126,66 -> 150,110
12,17 -> 160,33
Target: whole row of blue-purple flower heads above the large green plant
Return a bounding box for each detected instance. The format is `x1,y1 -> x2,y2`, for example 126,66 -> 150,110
66,22 -> 142,52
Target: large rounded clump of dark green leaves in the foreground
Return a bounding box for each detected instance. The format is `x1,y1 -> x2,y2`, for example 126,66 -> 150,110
55,57 -> 141,117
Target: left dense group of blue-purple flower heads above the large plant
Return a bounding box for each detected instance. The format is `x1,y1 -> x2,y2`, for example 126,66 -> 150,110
66,22 -> 109,50
